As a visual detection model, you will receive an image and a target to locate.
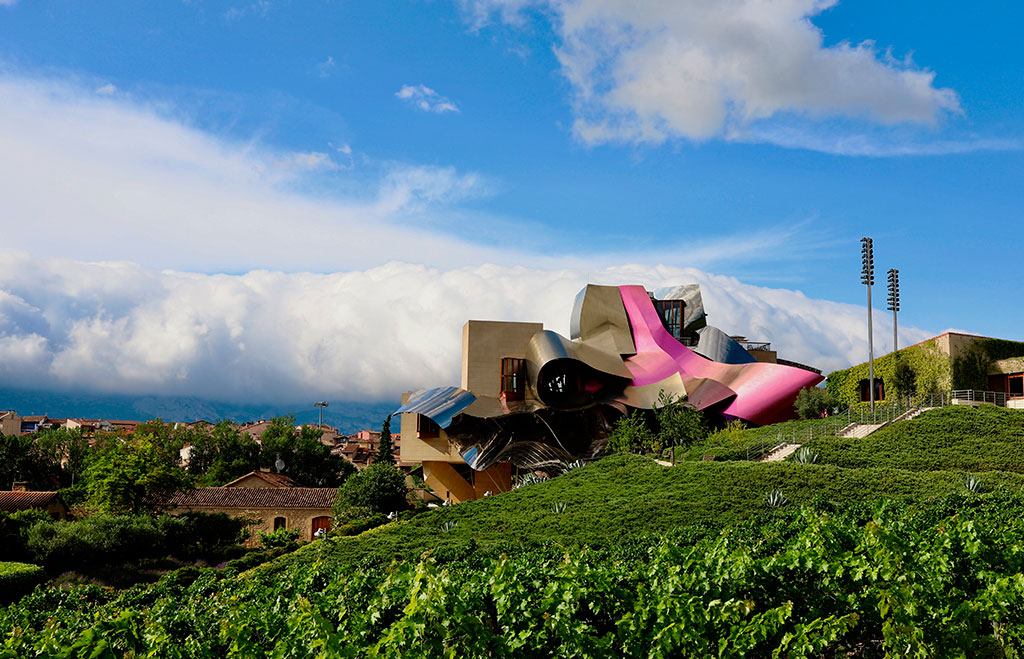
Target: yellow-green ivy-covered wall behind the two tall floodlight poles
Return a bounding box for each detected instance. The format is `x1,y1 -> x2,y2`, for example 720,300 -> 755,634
826,339 -> 953,407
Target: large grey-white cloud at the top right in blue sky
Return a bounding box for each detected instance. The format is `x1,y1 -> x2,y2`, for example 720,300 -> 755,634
463,0 -> 959,143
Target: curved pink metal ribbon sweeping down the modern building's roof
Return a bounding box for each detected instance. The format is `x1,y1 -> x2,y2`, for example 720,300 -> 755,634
618,285 -> 824,426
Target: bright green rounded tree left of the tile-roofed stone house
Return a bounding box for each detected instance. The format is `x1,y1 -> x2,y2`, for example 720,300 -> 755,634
85,431 -> 190,514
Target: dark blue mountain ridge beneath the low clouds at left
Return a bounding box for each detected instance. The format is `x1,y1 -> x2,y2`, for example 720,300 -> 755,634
0,389 -> 400,434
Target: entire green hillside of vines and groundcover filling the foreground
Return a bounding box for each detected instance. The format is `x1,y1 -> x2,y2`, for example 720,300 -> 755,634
6,410 -> 1024,659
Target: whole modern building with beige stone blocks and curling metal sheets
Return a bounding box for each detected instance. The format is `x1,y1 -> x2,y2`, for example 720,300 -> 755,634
396,284 -> 822,502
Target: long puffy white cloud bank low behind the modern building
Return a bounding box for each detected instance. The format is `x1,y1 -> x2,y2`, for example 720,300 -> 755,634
0,251 -> 929,402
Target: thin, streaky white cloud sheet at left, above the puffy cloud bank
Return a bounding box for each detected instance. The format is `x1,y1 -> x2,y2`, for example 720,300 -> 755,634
0,76 -> 519,271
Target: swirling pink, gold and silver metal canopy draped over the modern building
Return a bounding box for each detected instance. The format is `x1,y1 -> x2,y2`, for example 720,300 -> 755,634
396,284 -> 822,470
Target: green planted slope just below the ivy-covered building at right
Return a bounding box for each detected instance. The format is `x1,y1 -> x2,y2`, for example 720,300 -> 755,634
807,405 -> 1024,474
